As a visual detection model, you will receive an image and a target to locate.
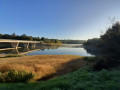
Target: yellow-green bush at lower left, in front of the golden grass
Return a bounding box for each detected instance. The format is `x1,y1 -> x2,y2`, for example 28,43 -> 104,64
0,70 -> 34,83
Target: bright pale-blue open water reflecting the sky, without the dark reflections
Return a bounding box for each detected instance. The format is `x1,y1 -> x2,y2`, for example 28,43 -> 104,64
27,44 -> 92,56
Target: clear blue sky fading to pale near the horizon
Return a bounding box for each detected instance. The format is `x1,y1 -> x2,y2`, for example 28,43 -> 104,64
0,0 -> 120,40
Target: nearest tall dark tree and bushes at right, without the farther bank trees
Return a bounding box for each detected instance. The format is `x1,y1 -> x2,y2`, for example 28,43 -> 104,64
97,22 -> 120,68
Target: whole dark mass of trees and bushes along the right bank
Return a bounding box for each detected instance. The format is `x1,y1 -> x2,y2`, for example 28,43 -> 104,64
84,22 -> 120,70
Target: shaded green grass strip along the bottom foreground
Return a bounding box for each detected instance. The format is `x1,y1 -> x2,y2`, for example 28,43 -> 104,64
0,69 -> 120,90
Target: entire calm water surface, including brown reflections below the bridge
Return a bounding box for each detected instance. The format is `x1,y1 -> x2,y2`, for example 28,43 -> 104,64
0,44 -> 92,56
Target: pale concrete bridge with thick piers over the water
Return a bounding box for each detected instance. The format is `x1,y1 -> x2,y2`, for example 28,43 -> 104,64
0,39 -> 42,49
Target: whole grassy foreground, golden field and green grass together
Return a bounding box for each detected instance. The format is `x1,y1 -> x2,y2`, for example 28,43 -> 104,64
0,55 -> 120,90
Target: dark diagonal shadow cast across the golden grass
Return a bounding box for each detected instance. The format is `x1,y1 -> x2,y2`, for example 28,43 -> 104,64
37,58 -> 95,81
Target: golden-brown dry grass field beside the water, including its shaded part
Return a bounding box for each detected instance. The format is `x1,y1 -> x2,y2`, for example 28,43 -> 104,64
0,55 -> 87,80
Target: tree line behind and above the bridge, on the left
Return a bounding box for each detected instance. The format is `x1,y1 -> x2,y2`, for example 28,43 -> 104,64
0,33 -> 61,43
